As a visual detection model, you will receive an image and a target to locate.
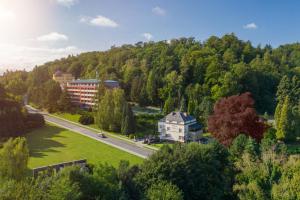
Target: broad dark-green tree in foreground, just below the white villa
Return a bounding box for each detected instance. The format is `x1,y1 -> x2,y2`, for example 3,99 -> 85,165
135,143 -> 231,199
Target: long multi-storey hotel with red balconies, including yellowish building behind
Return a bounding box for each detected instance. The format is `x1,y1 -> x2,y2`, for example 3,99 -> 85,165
53,71 -> 119,108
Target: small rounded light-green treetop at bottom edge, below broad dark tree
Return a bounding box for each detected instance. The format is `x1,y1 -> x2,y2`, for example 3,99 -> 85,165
146,181 -> 183,200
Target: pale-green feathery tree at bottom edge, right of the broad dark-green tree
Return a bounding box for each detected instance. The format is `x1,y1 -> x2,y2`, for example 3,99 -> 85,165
233,149 -> 285,200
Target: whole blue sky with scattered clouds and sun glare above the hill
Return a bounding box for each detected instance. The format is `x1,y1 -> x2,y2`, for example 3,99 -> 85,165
0,0 -> 300,74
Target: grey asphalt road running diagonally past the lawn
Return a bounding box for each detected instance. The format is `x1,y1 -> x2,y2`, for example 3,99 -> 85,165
27,106 -> 155,158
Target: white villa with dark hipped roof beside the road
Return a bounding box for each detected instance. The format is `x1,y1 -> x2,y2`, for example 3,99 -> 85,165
158,112 -> 203,142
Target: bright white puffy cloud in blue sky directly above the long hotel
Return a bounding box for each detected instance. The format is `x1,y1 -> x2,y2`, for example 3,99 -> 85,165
79,15 -> 119,28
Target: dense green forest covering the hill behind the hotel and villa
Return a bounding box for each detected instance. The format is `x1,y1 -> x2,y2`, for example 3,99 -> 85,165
0,34 -> 300,124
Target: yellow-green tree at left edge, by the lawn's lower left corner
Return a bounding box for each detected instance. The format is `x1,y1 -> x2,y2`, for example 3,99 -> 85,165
0,138 -> 29,180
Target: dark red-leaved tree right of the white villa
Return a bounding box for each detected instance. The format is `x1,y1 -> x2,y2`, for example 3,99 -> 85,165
208,92 -> 267,146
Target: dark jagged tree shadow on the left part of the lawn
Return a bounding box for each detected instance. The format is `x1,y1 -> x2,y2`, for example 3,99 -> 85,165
27,124 -> 65,158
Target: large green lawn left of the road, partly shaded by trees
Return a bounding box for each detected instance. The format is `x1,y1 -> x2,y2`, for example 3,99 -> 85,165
26,124 -> 143,168
